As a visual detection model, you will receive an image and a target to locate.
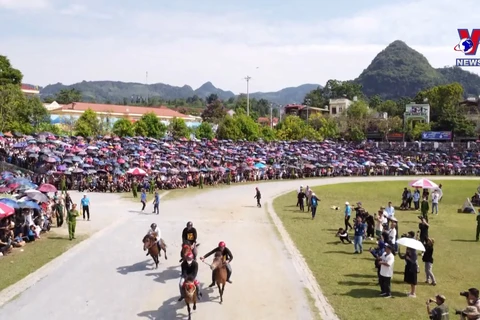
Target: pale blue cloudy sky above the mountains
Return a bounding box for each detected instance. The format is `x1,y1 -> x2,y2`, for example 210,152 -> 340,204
0,0 -> 480,93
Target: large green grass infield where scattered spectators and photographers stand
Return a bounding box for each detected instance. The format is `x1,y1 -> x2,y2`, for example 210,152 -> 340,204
273,179 -> 480,320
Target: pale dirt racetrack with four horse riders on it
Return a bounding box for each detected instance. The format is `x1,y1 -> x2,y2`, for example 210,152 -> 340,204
0,177 -> 472,320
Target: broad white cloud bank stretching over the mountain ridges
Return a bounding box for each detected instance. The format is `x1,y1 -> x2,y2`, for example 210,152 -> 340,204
0,0 -> 480,92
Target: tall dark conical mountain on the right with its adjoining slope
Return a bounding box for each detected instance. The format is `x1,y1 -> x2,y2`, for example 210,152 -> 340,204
354,40 -> 480,99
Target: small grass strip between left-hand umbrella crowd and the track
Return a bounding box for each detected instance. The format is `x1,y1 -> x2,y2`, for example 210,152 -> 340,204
0,232 -> 87,291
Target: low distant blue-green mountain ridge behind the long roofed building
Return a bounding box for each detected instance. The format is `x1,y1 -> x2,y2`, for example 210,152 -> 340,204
40,81 -> 319,104
